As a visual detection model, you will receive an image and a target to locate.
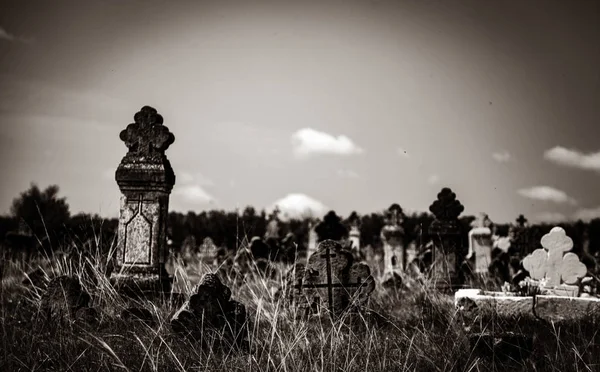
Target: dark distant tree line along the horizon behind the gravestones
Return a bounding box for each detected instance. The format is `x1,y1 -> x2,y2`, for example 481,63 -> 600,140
0,184 -> 600,262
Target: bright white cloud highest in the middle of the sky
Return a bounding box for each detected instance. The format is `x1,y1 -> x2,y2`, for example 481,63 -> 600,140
292,128 -> 364,158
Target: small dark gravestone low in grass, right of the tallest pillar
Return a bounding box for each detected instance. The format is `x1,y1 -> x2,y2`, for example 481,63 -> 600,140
171,274 -> 247,346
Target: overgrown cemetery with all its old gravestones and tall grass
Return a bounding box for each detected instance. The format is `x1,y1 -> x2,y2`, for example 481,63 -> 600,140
1,106 -> 600,371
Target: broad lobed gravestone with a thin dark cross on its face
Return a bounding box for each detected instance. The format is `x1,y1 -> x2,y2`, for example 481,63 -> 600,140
286,240 -> 375,318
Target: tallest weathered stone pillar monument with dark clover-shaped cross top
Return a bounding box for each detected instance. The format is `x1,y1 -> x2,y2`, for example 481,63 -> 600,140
111,106 -> 175,294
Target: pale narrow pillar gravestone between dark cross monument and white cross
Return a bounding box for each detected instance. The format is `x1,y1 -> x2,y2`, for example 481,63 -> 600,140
466,213 -> 493,275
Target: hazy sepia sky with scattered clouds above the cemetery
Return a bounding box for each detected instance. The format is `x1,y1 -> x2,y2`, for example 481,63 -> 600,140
0,0 -> 600,223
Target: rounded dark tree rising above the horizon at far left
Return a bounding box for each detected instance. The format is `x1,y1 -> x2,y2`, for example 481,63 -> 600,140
10,183 -> 70,250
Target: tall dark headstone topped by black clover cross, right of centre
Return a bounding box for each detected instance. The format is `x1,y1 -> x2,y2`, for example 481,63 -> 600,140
428,187 -> 464,290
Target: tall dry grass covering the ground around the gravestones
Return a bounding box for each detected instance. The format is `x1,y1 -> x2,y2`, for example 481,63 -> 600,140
0,237 -> 600,371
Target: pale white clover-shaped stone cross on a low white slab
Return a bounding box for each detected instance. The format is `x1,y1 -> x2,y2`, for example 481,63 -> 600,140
523,227 -> 587,296
